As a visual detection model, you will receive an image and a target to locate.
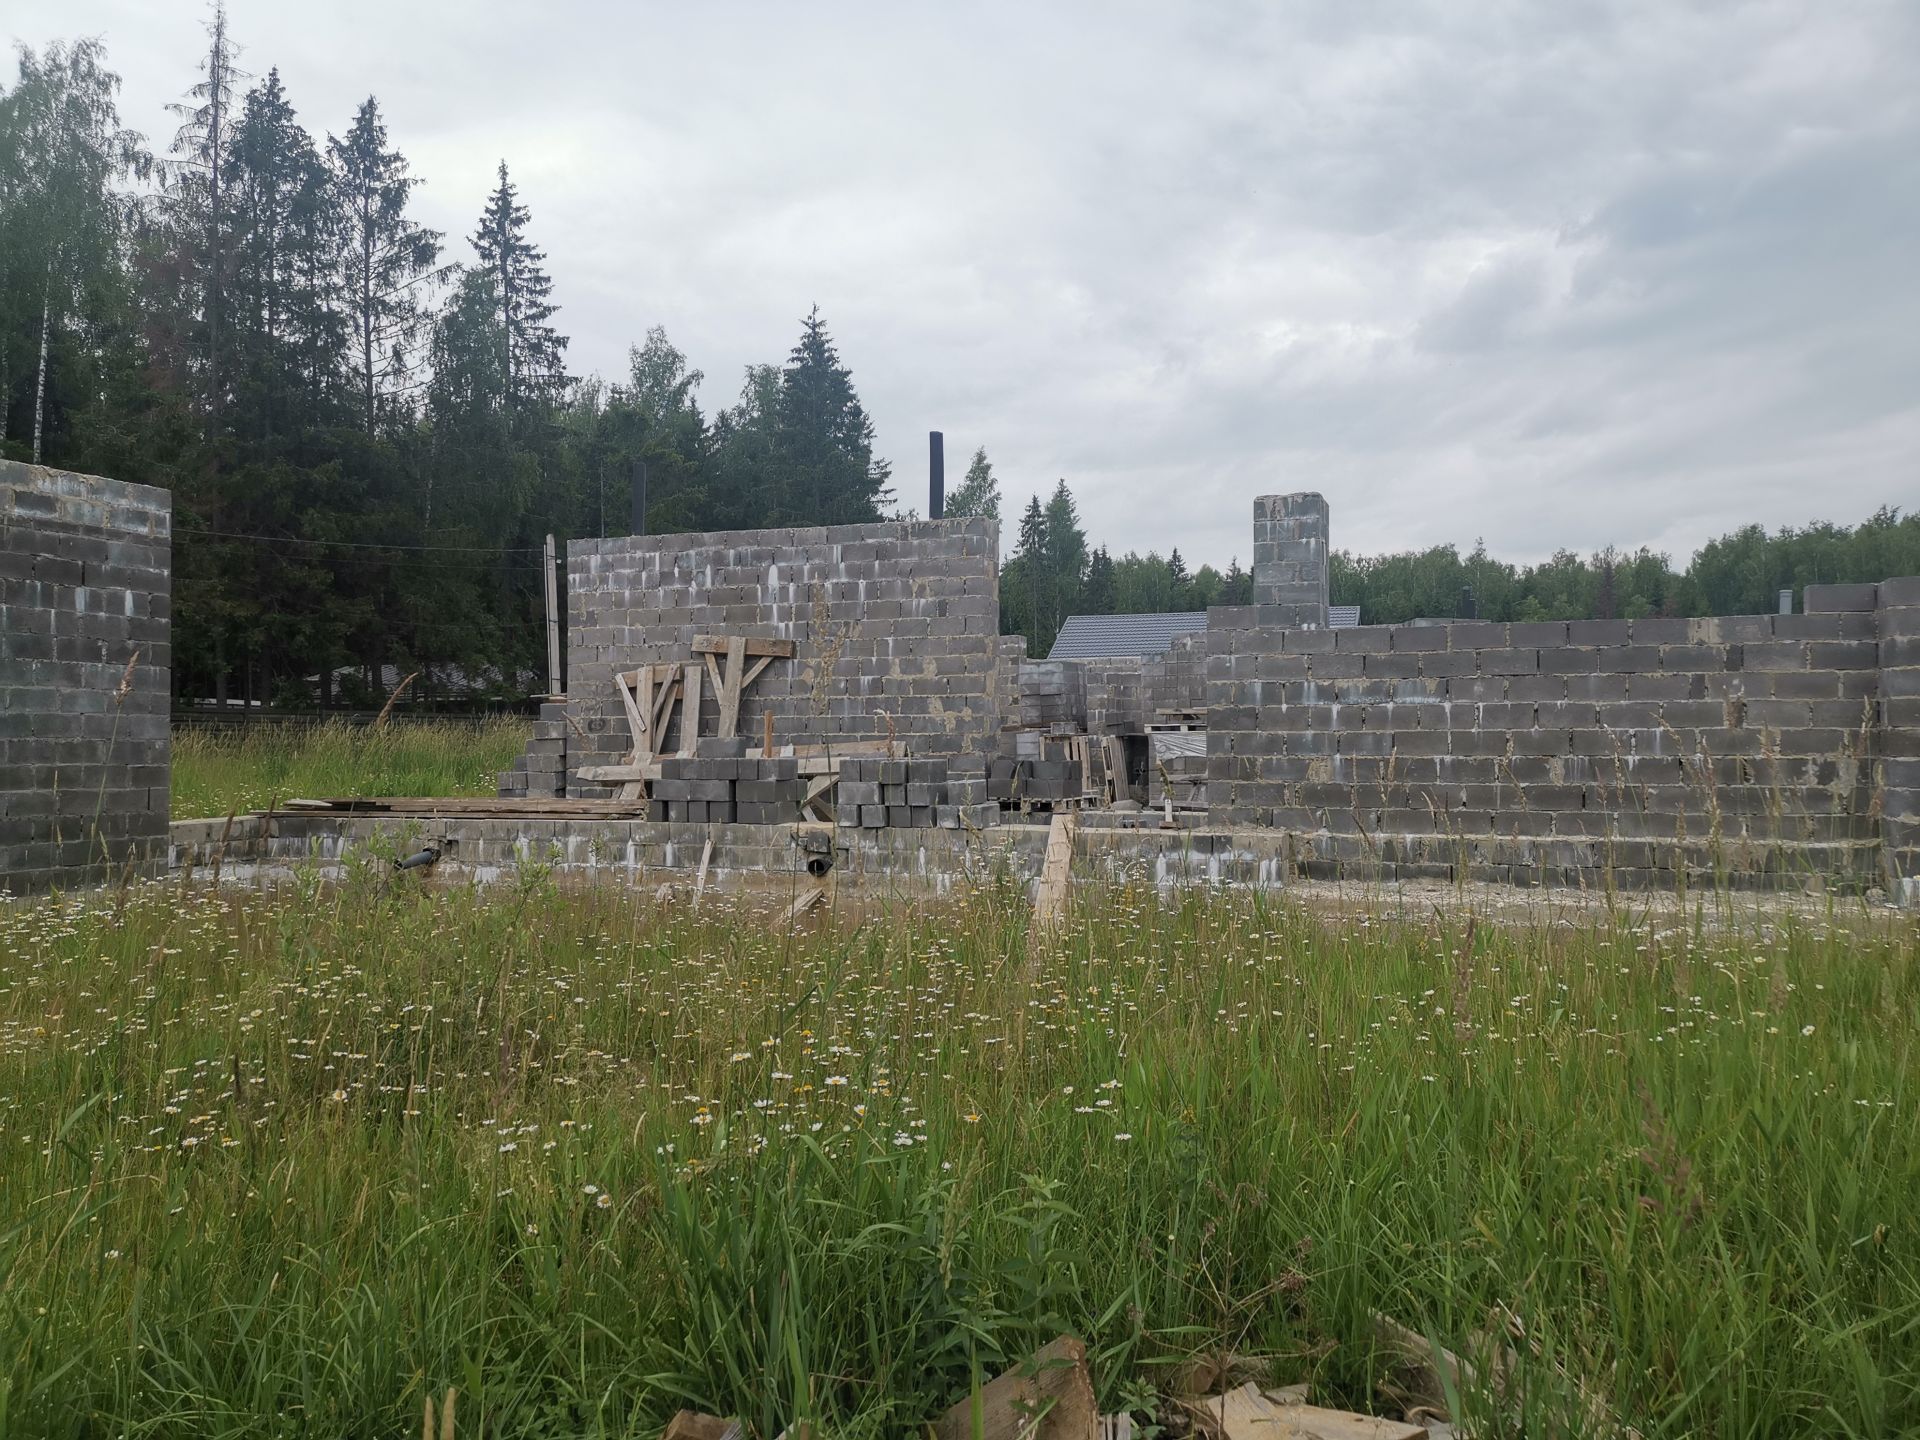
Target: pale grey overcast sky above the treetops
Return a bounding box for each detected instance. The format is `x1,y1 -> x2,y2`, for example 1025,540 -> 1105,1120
15,0 -> 1920,566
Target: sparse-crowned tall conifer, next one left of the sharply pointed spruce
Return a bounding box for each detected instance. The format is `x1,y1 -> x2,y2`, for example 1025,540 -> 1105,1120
337,96 -> 445,434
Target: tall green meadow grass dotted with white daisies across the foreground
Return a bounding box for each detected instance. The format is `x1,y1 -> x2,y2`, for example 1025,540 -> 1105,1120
0,866 -> 1920,1436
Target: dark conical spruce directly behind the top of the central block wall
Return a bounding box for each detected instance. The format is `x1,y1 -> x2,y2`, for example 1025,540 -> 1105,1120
776,305 -> 893,524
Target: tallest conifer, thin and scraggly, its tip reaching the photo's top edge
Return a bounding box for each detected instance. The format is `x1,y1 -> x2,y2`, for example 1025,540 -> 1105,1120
165,0 -> 246,432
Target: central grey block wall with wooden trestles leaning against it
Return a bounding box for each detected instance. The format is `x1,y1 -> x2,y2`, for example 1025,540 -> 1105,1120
566,518 -> 1004,795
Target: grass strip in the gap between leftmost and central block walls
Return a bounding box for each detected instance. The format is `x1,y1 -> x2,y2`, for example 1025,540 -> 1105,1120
173,716 -> 530,820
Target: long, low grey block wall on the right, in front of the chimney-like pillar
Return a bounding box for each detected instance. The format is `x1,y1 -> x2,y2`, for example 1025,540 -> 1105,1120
1208,599 -> 1908,885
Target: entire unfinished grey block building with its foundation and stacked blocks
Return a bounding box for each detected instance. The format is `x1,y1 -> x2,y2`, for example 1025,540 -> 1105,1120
0,453 -> 1920,900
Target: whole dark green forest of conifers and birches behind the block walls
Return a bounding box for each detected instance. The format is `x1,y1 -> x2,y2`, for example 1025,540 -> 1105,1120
11,8 -> 1920,707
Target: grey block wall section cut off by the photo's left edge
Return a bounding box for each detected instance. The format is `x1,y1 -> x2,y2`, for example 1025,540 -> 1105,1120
0,461 -> 173,893
